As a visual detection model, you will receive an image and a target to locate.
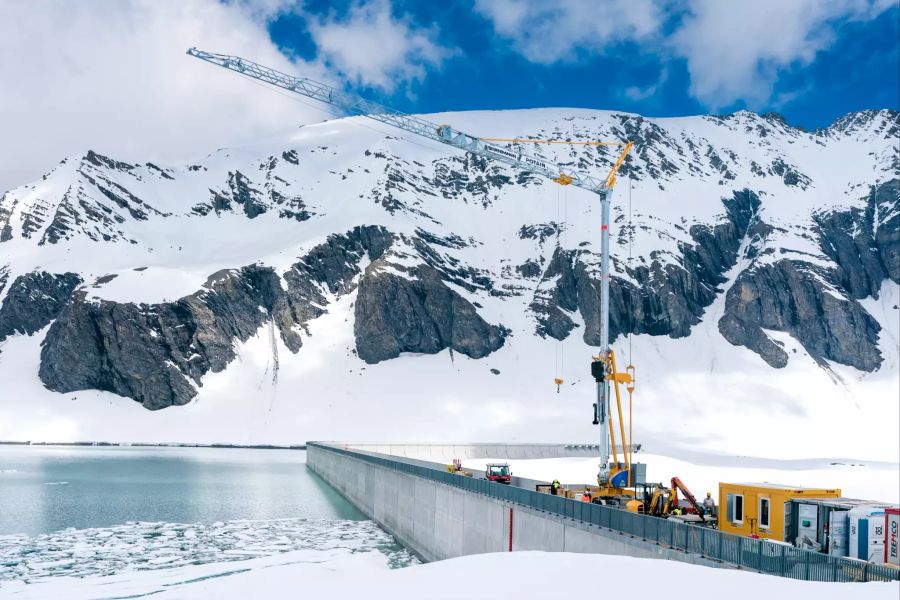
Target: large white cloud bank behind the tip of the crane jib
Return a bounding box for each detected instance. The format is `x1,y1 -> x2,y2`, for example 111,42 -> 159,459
0,0 -> 323,194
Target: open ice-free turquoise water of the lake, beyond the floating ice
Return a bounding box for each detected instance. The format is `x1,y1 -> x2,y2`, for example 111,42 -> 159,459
0,446 -> 365,535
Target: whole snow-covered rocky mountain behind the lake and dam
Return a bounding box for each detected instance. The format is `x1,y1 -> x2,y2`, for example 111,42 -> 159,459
0,109 -> 900,458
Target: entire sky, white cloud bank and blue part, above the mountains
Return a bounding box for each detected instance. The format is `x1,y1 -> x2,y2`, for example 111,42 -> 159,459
0,0 -> 900,193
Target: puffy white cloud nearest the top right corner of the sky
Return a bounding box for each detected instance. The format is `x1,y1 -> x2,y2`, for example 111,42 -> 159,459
671,0 -> 895,109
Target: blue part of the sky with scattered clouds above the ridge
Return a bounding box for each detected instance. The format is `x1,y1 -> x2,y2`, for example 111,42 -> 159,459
268,0 -> 900,129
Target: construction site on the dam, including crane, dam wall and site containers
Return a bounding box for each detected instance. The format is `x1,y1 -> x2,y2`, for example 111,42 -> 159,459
188,48 -> 900,581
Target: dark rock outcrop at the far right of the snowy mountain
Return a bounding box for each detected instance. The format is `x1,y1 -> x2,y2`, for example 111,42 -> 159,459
719,179 -> 900,371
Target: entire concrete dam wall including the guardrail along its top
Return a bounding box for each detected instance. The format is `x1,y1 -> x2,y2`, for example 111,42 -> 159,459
307,442 -> 900,582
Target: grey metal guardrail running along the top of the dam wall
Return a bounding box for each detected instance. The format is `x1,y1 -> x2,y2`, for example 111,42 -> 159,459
307,442 -> 900,582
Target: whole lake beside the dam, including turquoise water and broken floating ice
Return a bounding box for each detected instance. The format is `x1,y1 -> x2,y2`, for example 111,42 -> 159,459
0,445 -> 418,588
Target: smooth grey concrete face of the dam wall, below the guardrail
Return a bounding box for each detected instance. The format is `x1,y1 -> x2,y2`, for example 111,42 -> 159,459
307,443 -> 728,567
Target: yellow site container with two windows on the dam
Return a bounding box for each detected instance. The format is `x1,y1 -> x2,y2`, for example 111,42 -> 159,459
719,483 -> 841,541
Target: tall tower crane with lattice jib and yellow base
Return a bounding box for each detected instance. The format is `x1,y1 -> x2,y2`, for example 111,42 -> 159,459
187,48 -> 635,497
